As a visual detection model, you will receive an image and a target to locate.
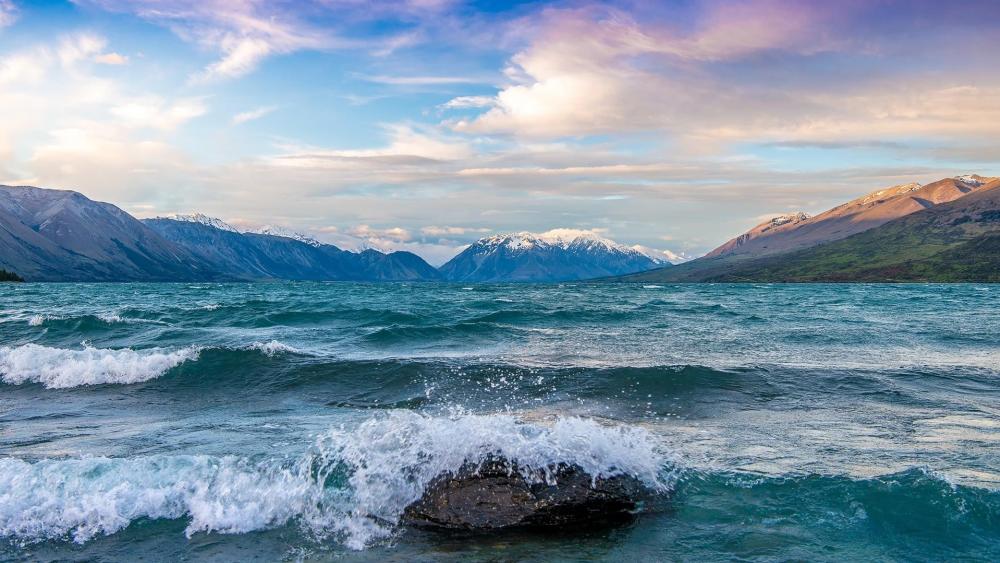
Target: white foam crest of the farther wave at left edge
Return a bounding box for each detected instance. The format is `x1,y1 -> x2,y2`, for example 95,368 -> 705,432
0,344 -> 199,389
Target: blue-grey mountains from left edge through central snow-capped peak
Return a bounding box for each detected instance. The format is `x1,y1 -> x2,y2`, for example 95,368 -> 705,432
0,186 -> 669,282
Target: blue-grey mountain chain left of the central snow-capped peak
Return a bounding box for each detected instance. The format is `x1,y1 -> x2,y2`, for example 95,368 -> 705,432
0,186 -> 440,282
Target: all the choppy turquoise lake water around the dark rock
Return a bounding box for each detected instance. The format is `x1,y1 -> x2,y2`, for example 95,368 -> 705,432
0,283 -> 1000,561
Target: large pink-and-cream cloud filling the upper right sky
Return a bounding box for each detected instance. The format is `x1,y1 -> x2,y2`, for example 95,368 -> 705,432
445,0 -> 1000,147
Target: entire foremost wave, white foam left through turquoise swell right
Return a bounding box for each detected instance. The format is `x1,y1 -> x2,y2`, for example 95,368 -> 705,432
0,411 -> 1000,556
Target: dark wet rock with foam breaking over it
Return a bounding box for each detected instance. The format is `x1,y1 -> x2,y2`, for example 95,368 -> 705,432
403,458 -> 644,530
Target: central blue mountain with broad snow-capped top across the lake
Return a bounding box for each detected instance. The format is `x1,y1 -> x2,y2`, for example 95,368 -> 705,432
441,229 -> 666,282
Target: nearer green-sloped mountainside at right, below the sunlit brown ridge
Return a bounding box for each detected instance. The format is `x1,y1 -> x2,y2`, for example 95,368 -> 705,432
622,177 -> 1000,282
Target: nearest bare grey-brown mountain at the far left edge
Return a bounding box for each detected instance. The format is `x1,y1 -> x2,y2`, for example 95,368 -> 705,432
0,186 -> 215,281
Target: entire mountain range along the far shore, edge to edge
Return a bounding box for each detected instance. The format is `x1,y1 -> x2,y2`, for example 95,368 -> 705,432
0,175 -> 1000,282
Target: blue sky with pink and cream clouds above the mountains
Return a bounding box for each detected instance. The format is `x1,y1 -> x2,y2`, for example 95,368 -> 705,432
0,0 -> 1000,264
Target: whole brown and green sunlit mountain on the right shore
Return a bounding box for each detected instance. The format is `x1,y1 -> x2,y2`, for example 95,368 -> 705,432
617,175 -> 1000,282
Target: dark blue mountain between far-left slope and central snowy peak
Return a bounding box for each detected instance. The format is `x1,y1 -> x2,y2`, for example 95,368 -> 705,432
144,218 -> 440,281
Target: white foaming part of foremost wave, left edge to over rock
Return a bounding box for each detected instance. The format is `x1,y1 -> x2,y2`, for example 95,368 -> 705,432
0,411 -> 672,549
